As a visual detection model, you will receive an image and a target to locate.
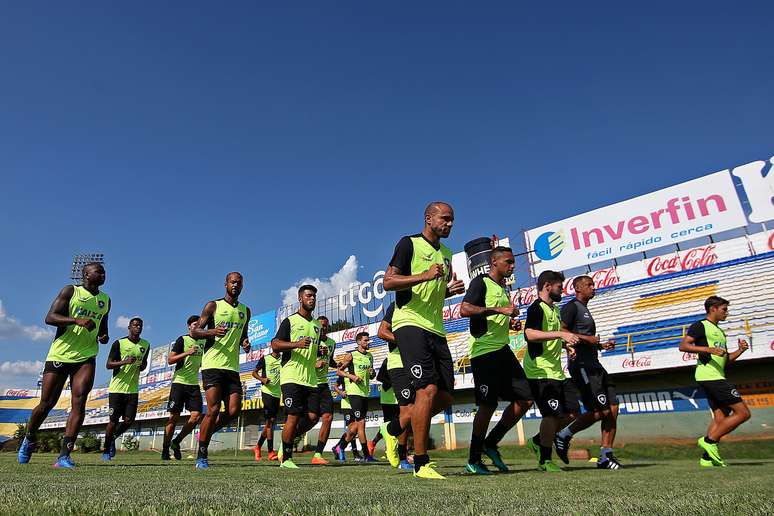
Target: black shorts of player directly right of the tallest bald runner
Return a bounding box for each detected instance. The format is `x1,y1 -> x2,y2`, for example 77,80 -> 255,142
470,346 -> 532,405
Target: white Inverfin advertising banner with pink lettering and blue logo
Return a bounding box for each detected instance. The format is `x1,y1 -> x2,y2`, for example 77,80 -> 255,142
526,170 -> 747,274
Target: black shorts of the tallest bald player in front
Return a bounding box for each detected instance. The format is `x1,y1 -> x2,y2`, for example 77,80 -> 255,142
393,326 -> 454,392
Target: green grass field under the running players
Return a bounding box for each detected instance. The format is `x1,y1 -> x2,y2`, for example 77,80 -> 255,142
0,441 -> 774,515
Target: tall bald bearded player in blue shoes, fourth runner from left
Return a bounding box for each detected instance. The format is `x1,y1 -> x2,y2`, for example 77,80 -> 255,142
191,272 -> 250,469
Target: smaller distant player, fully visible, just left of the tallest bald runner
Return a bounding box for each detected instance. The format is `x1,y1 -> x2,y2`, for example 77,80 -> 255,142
334,331 -> 376,462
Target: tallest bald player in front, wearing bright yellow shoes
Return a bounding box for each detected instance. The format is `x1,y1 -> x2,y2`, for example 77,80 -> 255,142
384,202 -> 465,479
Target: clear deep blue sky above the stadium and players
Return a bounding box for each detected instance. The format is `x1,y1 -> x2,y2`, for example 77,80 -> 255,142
0,2 -> 774,387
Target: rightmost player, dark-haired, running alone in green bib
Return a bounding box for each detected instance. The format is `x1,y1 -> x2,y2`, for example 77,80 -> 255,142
680,296 -> 750,467
